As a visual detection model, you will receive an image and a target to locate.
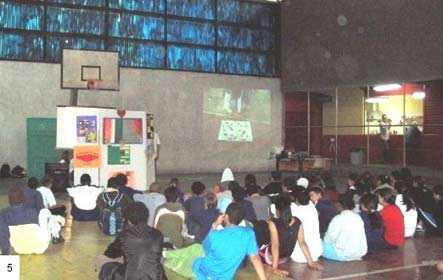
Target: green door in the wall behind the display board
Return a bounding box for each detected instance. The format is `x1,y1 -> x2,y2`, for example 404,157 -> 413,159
26,118 -> 59,179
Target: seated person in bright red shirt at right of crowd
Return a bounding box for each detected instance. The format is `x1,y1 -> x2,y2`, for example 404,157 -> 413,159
378,188 -> 405,248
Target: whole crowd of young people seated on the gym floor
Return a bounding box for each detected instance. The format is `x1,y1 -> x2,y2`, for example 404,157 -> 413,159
0,168 -> 443,279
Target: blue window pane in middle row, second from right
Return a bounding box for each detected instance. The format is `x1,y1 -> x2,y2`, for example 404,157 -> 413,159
167,20 -> 215,45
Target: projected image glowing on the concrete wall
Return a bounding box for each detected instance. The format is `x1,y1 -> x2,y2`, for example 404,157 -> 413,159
203,88 -> 271,142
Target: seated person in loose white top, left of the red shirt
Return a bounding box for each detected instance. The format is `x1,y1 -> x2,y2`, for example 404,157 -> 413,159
323,194 -> 368,261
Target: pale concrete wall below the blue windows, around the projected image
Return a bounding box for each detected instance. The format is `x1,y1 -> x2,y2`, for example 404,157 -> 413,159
0,61 -> 282,173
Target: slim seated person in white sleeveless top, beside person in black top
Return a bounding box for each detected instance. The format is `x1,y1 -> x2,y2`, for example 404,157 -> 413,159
291,190 -> 323,263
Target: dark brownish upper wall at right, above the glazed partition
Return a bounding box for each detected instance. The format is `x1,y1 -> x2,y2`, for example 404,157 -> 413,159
281,0 -> 443,92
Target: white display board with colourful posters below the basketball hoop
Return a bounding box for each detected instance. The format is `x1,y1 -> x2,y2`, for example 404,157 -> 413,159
57,107 -> 147,190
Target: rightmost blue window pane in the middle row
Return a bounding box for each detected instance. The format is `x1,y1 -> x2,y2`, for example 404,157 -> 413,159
218,25 -> 275,51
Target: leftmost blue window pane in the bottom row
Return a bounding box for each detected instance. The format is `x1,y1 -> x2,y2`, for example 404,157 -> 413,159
0,32 -> 43,61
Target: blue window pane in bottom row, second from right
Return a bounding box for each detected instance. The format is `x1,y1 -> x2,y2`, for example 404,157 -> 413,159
168,45 -> 215,72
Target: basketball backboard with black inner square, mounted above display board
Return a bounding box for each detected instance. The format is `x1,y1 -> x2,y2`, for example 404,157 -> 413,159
61,49 -> 120,91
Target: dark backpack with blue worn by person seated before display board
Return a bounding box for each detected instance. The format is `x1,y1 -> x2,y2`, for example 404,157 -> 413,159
99,192 -> 124,235
